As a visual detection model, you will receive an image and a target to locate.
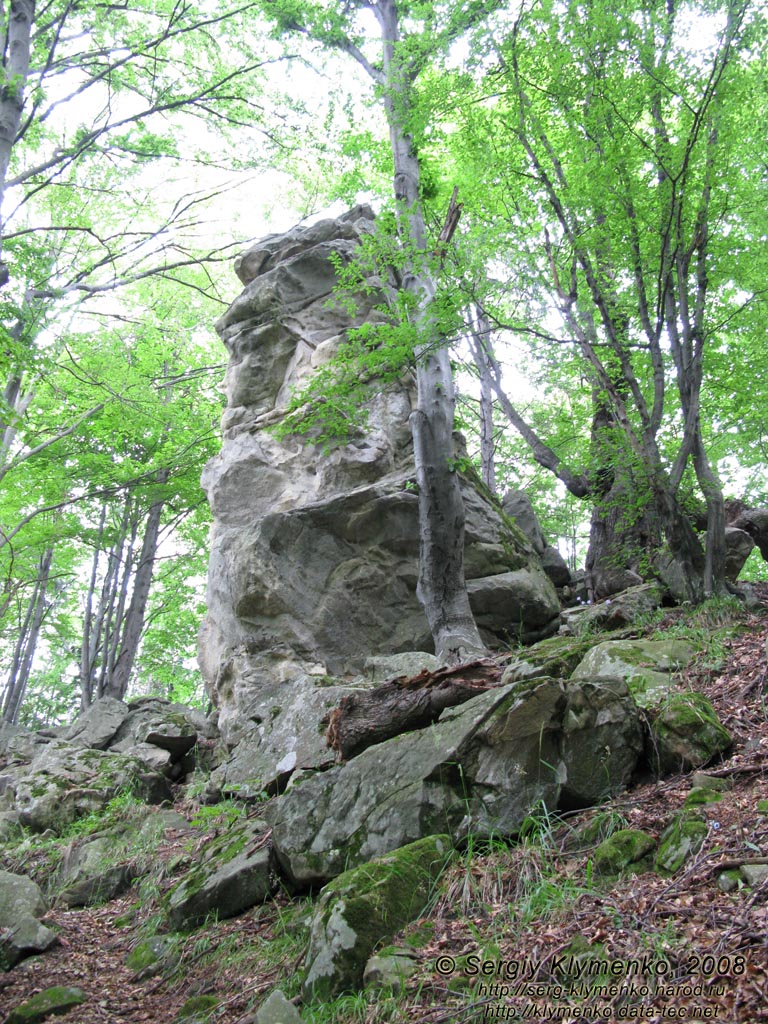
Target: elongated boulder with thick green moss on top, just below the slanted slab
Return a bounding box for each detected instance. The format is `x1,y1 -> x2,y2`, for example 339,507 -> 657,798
303,836 -> 453,1001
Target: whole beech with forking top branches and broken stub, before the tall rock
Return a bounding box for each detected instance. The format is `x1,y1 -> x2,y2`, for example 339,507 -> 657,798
264,0 -> 520,662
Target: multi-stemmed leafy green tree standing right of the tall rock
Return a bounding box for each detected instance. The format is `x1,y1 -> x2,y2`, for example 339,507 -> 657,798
444,0 -> 765,600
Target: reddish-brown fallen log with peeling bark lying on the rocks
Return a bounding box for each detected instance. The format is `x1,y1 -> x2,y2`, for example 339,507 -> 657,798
326,658 -> 503,761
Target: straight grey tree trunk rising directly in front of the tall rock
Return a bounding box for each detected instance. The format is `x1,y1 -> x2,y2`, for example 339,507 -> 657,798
376,0 -> 484,664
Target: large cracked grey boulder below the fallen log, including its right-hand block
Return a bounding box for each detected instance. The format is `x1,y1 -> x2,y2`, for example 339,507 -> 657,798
270,679 -> 642,886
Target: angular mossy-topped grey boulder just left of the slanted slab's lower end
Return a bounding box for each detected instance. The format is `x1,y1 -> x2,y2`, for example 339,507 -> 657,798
168,820 -> 272,932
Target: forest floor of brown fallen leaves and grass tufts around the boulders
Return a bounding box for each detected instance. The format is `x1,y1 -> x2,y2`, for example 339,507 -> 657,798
0,607 -> 768,1024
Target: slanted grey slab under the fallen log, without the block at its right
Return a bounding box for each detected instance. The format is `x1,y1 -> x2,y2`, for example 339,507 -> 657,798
269,679 -> 566,885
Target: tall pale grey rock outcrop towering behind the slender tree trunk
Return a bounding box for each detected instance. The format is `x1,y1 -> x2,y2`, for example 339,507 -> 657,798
200,207 -> 559,782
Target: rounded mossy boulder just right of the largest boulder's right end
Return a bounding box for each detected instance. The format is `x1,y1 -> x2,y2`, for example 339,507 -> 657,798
651,691 -> 733,773
